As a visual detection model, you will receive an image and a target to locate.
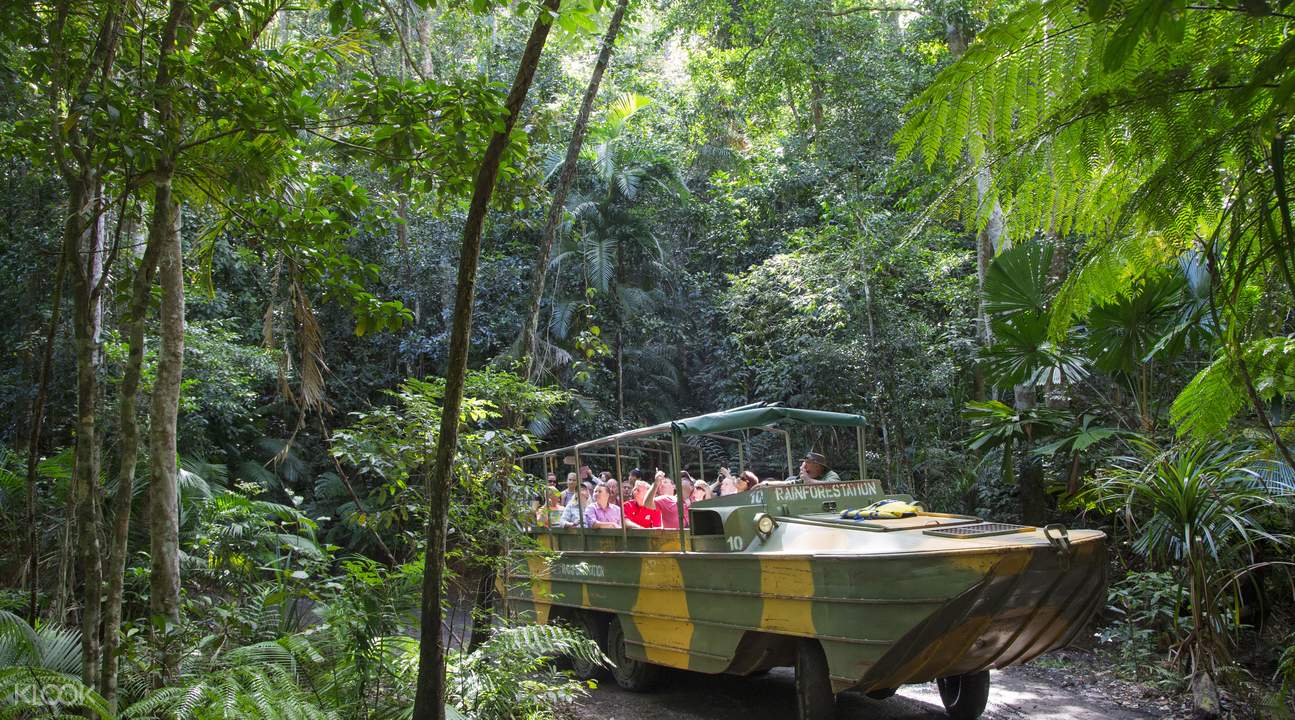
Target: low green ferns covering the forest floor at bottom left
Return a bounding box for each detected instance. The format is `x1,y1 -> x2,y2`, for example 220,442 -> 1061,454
0,603 -> 595,720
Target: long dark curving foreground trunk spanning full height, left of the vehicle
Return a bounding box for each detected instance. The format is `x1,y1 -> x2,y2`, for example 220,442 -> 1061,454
413,0 -> 561,720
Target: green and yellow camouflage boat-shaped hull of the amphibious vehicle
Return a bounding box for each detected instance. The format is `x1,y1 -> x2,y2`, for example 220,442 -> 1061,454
504,480 -> 1107,692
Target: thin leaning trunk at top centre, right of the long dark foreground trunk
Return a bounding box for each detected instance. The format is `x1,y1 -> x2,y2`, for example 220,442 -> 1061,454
522,0 -> 629,383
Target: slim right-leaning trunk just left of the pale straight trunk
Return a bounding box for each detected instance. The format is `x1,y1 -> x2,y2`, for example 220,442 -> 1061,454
101,216 -> 161,715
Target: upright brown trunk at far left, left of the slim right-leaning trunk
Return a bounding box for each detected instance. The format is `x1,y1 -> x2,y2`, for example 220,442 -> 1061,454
63,170 -> 104,688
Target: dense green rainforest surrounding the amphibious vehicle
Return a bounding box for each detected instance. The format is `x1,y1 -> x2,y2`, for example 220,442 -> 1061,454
0,0 -> 1295,717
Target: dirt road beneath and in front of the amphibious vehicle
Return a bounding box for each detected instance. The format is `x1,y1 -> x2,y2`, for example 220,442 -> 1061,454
576,667 -> 1176,720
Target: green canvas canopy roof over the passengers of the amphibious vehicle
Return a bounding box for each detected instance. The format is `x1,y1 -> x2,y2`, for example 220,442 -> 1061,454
512,403 -> 868,460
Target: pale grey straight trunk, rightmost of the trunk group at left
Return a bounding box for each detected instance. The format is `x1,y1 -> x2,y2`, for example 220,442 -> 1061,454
149,189 -> 184,680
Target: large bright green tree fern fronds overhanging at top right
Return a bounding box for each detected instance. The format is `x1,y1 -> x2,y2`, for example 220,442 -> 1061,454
896,0 -> 1291,325
